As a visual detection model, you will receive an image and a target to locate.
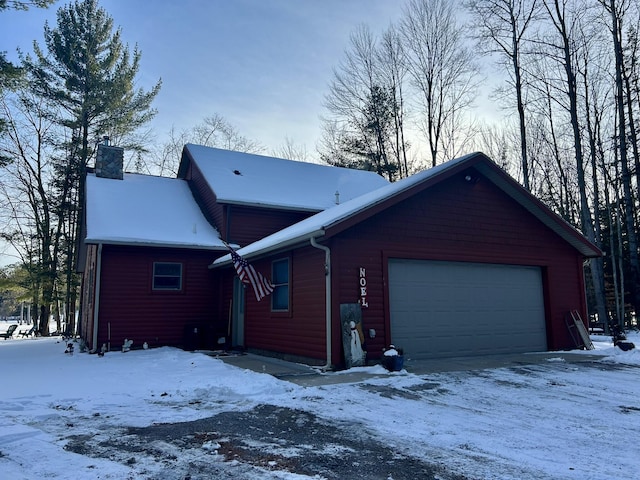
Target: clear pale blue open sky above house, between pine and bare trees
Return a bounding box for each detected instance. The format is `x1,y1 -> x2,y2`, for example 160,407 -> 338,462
0,0 -> 404,153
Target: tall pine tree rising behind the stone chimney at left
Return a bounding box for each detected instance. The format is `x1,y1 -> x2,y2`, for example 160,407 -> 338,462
24,0 -> 160,333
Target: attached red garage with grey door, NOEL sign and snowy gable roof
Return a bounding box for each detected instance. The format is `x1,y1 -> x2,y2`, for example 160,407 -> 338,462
213,153 -> 601,366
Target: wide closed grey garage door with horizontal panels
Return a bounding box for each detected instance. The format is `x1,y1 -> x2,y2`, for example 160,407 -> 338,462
389,259 -> 547,359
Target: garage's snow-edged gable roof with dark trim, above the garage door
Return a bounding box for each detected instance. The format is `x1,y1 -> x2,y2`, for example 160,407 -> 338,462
210,152 -> 600,268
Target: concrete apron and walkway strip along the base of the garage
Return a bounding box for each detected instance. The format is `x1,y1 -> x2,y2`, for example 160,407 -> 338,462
212,352 -> 602,387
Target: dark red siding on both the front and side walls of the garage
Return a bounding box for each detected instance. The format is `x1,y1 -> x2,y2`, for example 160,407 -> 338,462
232,172 -> 585,365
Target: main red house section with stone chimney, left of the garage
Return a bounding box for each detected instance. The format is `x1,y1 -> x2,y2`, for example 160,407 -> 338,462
79,145 -> 388,350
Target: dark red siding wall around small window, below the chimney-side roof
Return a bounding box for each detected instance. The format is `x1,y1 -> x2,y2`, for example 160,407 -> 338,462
92,245 -> 226,349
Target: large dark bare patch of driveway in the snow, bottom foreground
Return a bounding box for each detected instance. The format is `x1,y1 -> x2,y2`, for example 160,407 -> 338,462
66,405 -> 467,480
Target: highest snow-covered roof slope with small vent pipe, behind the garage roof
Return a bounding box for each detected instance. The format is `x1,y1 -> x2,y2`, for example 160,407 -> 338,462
178,144 -> 389,212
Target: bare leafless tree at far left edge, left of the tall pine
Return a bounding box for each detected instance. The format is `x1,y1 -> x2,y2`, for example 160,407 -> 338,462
0,84 -> 61,332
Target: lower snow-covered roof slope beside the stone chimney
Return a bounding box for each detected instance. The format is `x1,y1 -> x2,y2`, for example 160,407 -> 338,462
85,173 -> 226,250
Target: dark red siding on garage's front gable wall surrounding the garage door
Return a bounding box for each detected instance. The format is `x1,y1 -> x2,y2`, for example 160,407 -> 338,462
332,171 -> 585,361
